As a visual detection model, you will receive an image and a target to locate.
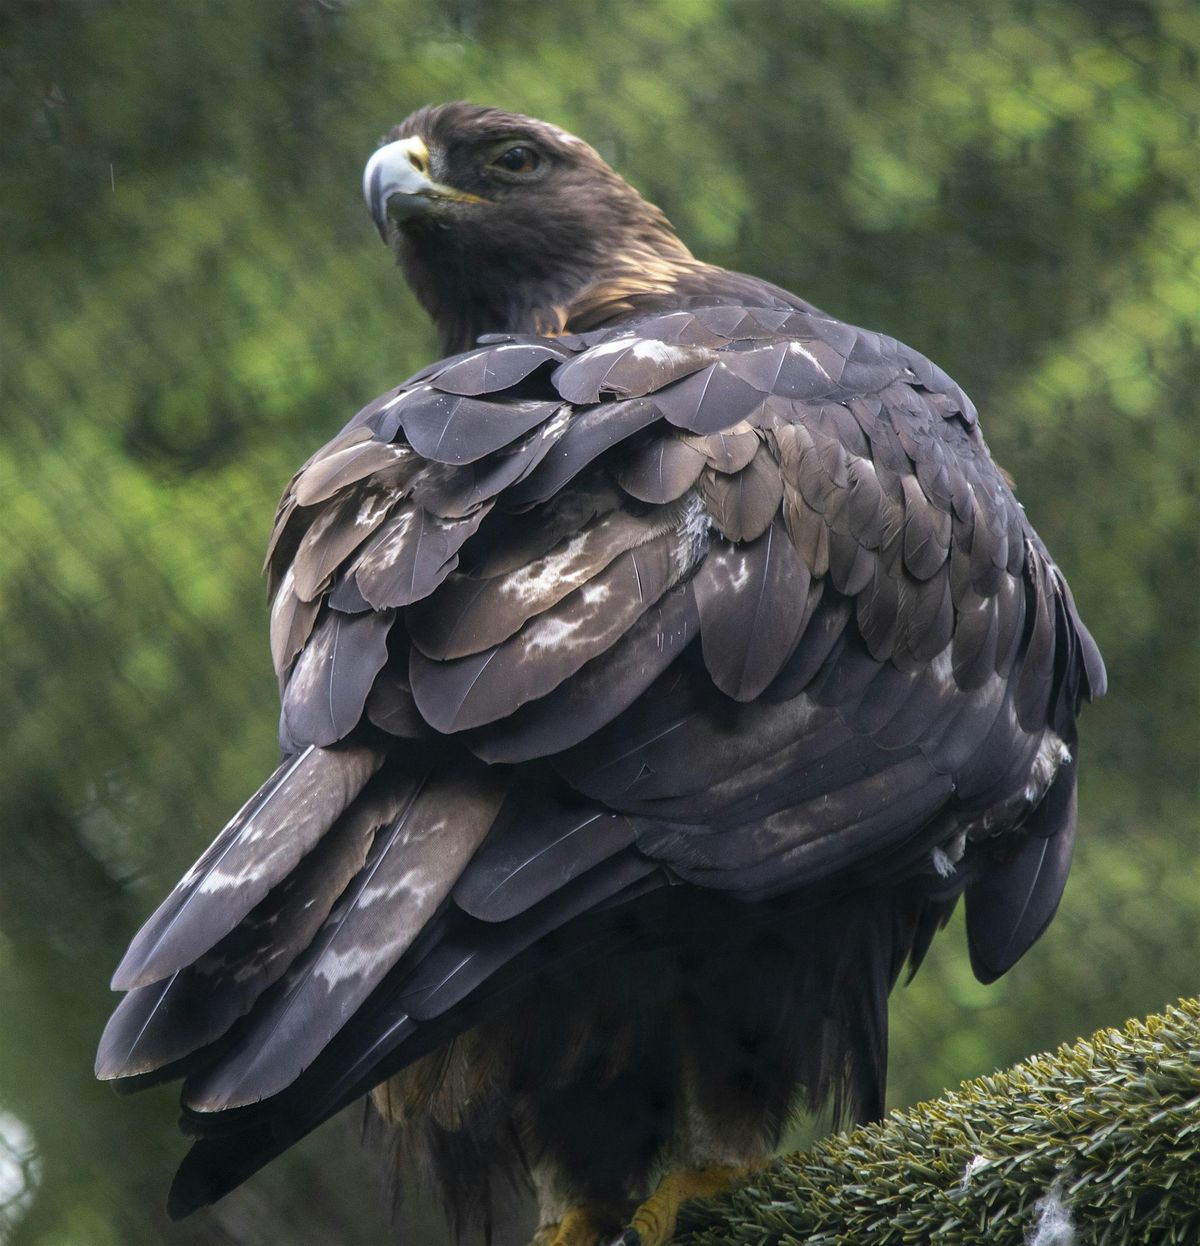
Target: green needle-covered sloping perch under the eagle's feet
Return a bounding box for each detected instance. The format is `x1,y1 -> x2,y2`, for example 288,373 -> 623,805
682,999 -> 1200,1246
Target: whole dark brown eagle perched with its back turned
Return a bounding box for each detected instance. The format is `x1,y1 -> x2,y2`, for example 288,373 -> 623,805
97,105 -> 1104,1246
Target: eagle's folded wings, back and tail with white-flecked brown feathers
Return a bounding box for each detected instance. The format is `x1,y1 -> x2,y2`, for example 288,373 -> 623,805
98,296 -> 1104,1210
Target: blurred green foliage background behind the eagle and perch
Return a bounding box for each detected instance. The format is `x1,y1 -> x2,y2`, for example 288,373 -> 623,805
0,0 -> 1200,1246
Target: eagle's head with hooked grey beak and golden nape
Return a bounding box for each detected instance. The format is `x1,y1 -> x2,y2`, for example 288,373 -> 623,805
363,102 -> 699,351
